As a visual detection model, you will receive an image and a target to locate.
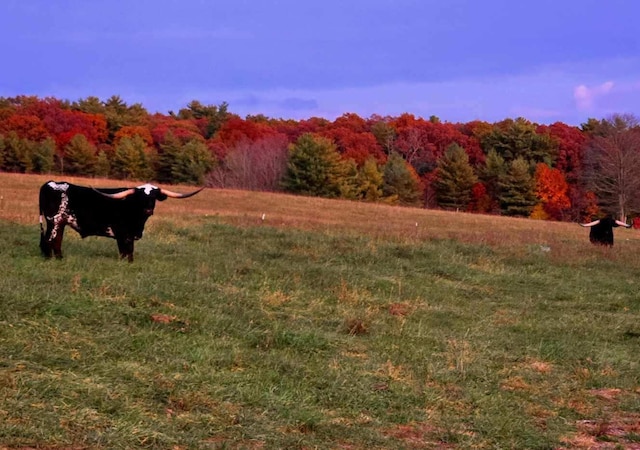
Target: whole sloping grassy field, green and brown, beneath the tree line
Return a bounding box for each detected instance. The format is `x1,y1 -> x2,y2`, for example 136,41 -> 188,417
0,174 -> 640,449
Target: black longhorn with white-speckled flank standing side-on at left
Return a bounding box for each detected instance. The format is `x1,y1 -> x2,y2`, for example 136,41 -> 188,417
40,181 -> 204,262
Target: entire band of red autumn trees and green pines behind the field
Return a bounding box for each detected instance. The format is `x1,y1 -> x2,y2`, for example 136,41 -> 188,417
0,96 -> 640,220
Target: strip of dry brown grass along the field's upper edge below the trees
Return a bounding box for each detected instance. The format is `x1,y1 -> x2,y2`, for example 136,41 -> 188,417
0,173 -> 624,253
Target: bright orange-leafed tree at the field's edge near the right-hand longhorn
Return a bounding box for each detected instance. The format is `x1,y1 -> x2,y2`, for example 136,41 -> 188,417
534,163 -> 571,220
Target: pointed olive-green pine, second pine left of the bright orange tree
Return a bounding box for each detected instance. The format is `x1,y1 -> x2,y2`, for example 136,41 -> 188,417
433,143 -> 478,210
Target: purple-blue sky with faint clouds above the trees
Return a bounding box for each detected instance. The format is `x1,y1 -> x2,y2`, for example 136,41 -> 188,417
0,0 -> 640,125
